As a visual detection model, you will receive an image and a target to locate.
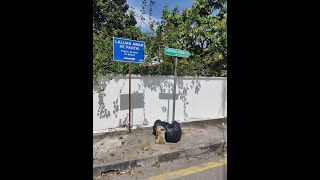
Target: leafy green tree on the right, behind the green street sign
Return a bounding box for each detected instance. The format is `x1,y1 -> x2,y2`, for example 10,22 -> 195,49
157,0 -> 227,76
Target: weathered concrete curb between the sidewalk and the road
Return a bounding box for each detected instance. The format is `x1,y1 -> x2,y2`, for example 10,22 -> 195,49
93,142 -> 227,177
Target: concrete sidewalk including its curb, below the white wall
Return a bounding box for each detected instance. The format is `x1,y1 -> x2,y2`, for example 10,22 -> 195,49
93,118 -> 227,177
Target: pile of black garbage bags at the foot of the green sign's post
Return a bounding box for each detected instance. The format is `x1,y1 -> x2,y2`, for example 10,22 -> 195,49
152,119 -> 182,143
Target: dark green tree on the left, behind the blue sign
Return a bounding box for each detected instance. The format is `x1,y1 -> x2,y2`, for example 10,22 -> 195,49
93,0 -> 141,85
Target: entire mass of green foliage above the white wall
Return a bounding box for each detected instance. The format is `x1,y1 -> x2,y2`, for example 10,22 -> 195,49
93,0 -> 227,84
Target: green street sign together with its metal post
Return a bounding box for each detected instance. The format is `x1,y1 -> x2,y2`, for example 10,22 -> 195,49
164,48 -> 190,122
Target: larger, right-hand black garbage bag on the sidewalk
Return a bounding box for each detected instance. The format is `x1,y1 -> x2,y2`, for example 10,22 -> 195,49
165,121 -> 182,143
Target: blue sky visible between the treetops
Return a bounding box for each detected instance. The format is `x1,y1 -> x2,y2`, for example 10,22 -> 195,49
127,0 -> 219,32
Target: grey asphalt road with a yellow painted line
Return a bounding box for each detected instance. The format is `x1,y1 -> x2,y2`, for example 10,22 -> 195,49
99,155 -> 227,180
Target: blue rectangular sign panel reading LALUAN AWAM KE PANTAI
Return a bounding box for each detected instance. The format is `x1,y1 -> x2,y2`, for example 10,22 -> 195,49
113,37 -> 144,63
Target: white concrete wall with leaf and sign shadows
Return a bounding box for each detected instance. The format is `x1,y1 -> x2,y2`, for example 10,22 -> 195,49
93,75 -> 227,133
